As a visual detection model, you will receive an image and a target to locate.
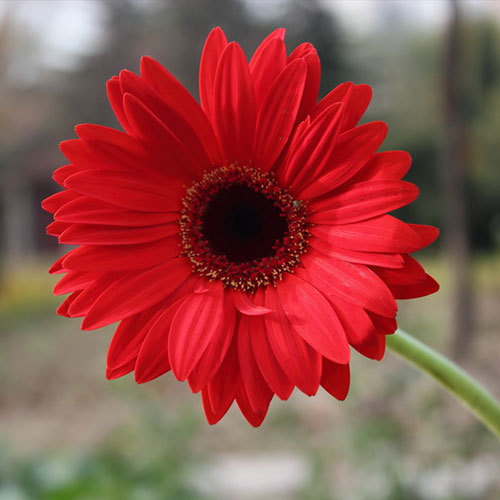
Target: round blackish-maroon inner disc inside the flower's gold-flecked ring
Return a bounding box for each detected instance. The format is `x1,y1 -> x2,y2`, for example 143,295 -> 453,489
201,184 -> 288,262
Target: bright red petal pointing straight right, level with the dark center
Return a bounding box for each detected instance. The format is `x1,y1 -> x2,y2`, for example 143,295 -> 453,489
310,215 -> 425,253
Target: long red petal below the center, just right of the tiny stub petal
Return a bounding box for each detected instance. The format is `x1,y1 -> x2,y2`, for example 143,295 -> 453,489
264,284 -> 322,396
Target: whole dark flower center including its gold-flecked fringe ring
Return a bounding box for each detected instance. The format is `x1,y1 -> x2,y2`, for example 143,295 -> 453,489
180,166 -> 309,292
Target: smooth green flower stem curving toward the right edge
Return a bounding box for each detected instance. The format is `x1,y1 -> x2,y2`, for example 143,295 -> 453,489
387,329 -> 500,439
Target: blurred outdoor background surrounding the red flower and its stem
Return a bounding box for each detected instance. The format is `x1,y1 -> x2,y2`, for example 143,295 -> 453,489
0,0 -> 500,500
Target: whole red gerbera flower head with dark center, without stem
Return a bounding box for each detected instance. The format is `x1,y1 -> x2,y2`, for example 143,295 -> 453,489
43,28 -> 438,426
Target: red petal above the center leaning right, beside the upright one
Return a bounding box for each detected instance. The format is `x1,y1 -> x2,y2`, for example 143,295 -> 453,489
255,59 -> 307,171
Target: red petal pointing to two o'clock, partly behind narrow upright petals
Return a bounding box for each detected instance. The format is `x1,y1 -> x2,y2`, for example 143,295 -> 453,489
298,122 -> 387,199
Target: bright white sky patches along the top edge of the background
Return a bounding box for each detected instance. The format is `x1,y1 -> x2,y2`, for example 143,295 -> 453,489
0,0 -> 500,69
